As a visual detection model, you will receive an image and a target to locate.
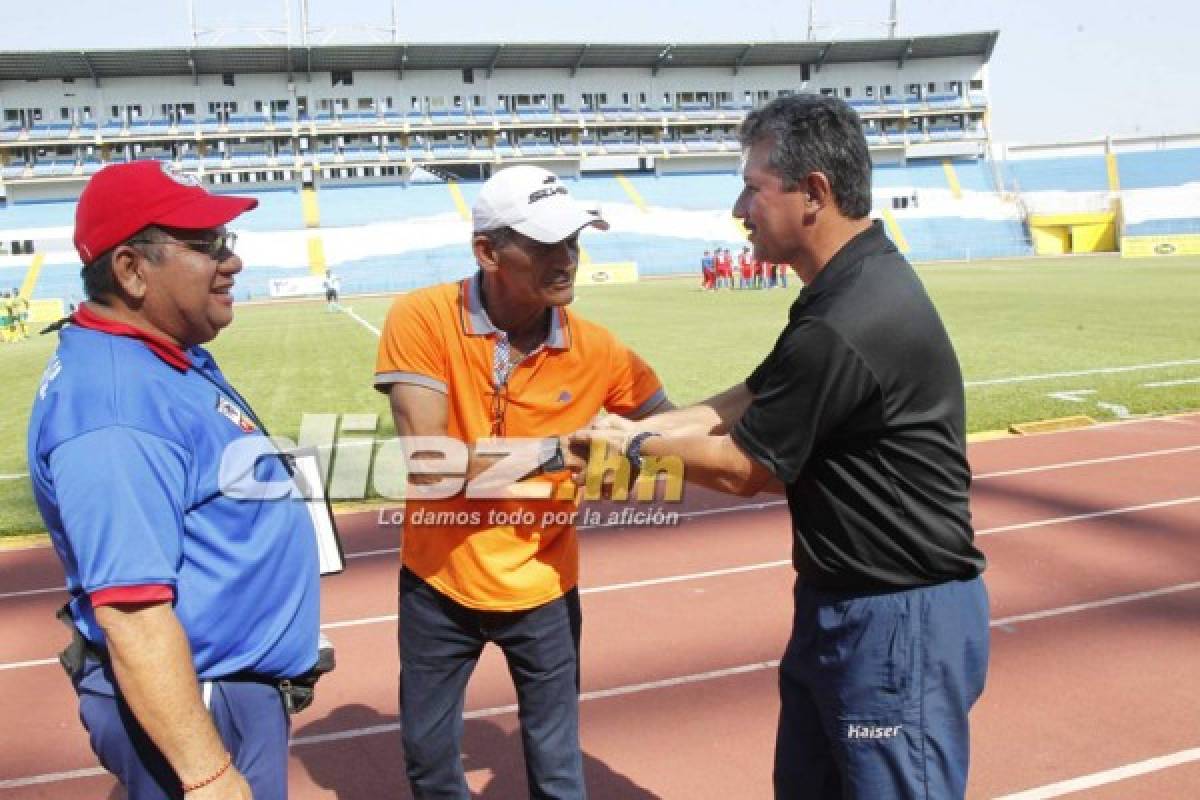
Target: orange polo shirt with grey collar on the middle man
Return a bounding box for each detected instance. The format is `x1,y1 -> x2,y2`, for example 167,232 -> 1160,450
374,275 -> 665,610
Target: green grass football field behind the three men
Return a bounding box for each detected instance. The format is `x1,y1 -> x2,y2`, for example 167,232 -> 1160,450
0,258 -> 1200,535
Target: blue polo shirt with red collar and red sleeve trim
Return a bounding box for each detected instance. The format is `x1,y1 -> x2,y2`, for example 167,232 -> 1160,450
29,311 -> 319,680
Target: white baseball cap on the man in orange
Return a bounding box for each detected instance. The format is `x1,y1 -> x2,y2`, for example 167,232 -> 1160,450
470,164 -> 608,245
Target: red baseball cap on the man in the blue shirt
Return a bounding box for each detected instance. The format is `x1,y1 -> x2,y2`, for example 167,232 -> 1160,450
74,161 -> 258,264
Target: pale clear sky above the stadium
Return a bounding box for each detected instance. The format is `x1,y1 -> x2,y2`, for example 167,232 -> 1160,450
0,0 -> 1200,143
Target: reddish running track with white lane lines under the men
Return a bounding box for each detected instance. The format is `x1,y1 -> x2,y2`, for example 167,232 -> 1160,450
0,415 -> 1200,800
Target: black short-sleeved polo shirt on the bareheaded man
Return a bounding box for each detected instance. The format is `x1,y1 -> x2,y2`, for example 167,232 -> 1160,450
733,221 -> 984,591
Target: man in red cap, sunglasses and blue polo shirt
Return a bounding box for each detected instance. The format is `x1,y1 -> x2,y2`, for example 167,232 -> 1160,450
29,161 -> 319,800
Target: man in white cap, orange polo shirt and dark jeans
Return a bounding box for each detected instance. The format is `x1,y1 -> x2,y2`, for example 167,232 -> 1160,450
374,166 -> 671,798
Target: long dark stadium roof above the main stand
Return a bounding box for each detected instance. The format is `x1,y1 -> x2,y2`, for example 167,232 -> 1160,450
0,31 -> 1000,82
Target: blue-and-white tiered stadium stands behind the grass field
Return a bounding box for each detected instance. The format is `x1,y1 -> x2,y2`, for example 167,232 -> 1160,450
0,32 -> 1200,297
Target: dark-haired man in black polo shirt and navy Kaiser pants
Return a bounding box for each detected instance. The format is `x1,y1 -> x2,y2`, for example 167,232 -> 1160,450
576,95 -> 988,800
